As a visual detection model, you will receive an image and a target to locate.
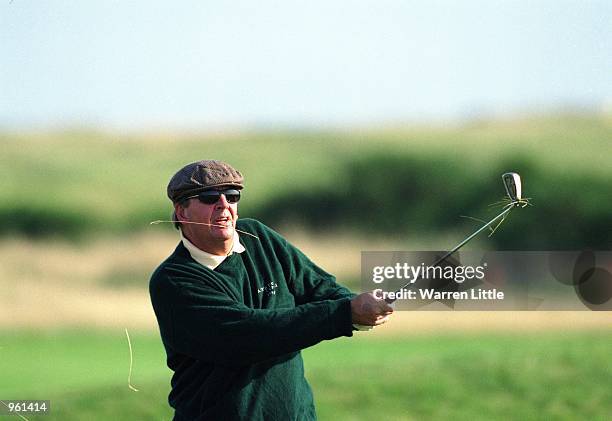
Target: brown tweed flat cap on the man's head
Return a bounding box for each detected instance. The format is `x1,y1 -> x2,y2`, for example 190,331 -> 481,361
167,159 -> 244,203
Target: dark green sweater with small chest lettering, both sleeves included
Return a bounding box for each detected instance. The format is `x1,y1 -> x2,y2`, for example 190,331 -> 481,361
149,219 -> 353,421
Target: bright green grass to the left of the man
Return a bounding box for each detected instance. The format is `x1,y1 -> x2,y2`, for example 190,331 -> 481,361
0,330 -> 172,421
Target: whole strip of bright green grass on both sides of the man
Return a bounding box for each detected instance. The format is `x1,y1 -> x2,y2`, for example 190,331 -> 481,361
0,331 -> 612,420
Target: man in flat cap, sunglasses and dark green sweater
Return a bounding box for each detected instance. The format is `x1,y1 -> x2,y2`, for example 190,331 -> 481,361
149,160 -> 393,421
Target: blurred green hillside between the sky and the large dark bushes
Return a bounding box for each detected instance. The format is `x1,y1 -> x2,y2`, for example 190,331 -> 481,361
0,115 -> 612,238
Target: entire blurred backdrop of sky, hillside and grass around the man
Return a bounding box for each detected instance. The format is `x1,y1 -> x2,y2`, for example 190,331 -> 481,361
0,0 -> 612,420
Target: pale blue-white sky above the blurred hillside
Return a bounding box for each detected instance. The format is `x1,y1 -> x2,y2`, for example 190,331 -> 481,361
0,0 -> 612,128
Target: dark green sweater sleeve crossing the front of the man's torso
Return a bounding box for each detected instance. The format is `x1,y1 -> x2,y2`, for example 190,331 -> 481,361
151,278 -> 352,365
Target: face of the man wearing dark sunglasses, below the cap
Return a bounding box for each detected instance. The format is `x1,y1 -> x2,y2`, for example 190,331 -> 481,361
175,189 -> 238,244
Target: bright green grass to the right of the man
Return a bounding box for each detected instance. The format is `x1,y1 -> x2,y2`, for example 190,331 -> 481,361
306,334 -> 612,420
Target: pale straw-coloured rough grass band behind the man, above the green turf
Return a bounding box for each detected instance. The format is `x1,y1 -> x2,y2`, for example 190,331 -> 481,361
0,232 -> 612,334
